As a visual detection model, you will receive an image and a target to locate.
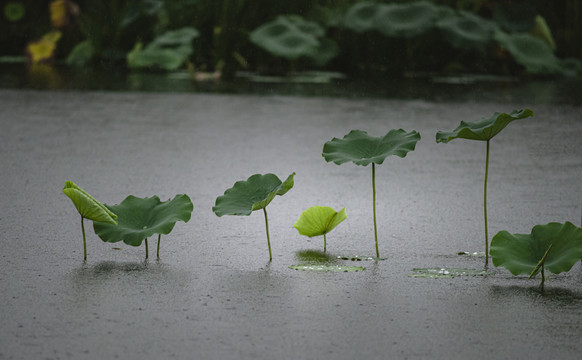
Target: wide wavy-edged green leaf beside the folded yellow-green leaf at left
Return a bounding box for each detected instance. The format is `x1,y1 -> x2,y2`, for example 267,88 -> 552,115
93,195 -> 194,246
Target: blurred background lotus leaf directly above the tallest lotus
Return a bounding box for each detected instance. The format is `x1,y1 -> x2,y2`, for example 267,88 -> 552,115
436,11 -> 497,50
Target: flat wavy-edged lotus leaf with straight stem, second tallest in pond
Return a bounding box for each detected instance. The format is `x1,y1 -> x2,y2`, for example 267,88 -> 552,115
322,129 -> 420,258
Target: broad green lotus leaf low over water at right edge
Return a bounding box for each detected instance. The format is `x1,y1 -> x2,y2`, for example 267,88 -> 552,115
491,222 -> 582,275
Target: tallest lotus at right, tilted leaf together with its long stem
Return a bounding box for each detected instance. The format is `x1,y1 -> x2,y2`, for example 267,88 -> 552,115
436,109 -> 533,267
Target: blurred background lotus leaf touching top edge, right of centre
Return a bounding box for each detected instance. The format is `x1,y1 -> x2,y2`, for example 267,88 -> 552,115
375,1 -> 439,38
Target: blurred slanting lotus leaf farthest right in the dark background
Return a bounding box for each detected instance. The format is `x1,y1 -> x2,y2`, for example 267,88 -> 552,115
495,30 -> 562,74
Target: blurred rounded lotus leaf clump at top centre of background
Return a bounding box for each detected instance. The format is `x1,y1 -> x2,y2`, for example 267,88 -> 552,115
250,15 -> 338,65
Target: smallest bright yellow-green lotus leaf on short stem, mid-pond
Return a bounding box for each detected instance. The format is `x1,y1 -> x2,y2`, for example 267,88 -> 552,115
293,206 -> 348,254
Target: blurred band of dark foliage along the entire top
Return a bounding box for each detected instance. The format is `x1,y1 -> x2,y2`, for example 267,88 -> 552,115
0,0 -> 582,79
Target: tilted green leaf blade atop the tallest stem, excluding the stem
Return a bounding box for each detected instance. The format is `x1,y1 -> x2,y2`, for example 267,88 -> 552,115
436,109 -> 533,143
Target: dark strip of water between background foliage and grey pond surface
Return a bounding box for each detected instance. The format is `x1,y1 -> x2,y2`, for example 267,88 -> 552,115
0,64 -> 582,105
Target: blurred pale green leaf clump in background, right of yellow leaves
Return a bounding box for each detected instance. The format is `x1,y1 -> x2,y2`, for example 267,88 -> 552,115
127,27 -> 199,71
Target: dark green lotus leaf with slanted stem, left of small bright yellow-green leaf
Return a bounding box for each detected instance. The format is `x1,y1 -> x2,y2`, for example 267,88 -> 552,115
212,173 -> 295,261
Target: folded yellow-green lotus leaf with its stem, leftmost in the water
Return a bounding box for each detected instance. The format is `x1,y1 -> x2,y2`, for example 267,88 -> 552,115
63,181 -> 117,260
